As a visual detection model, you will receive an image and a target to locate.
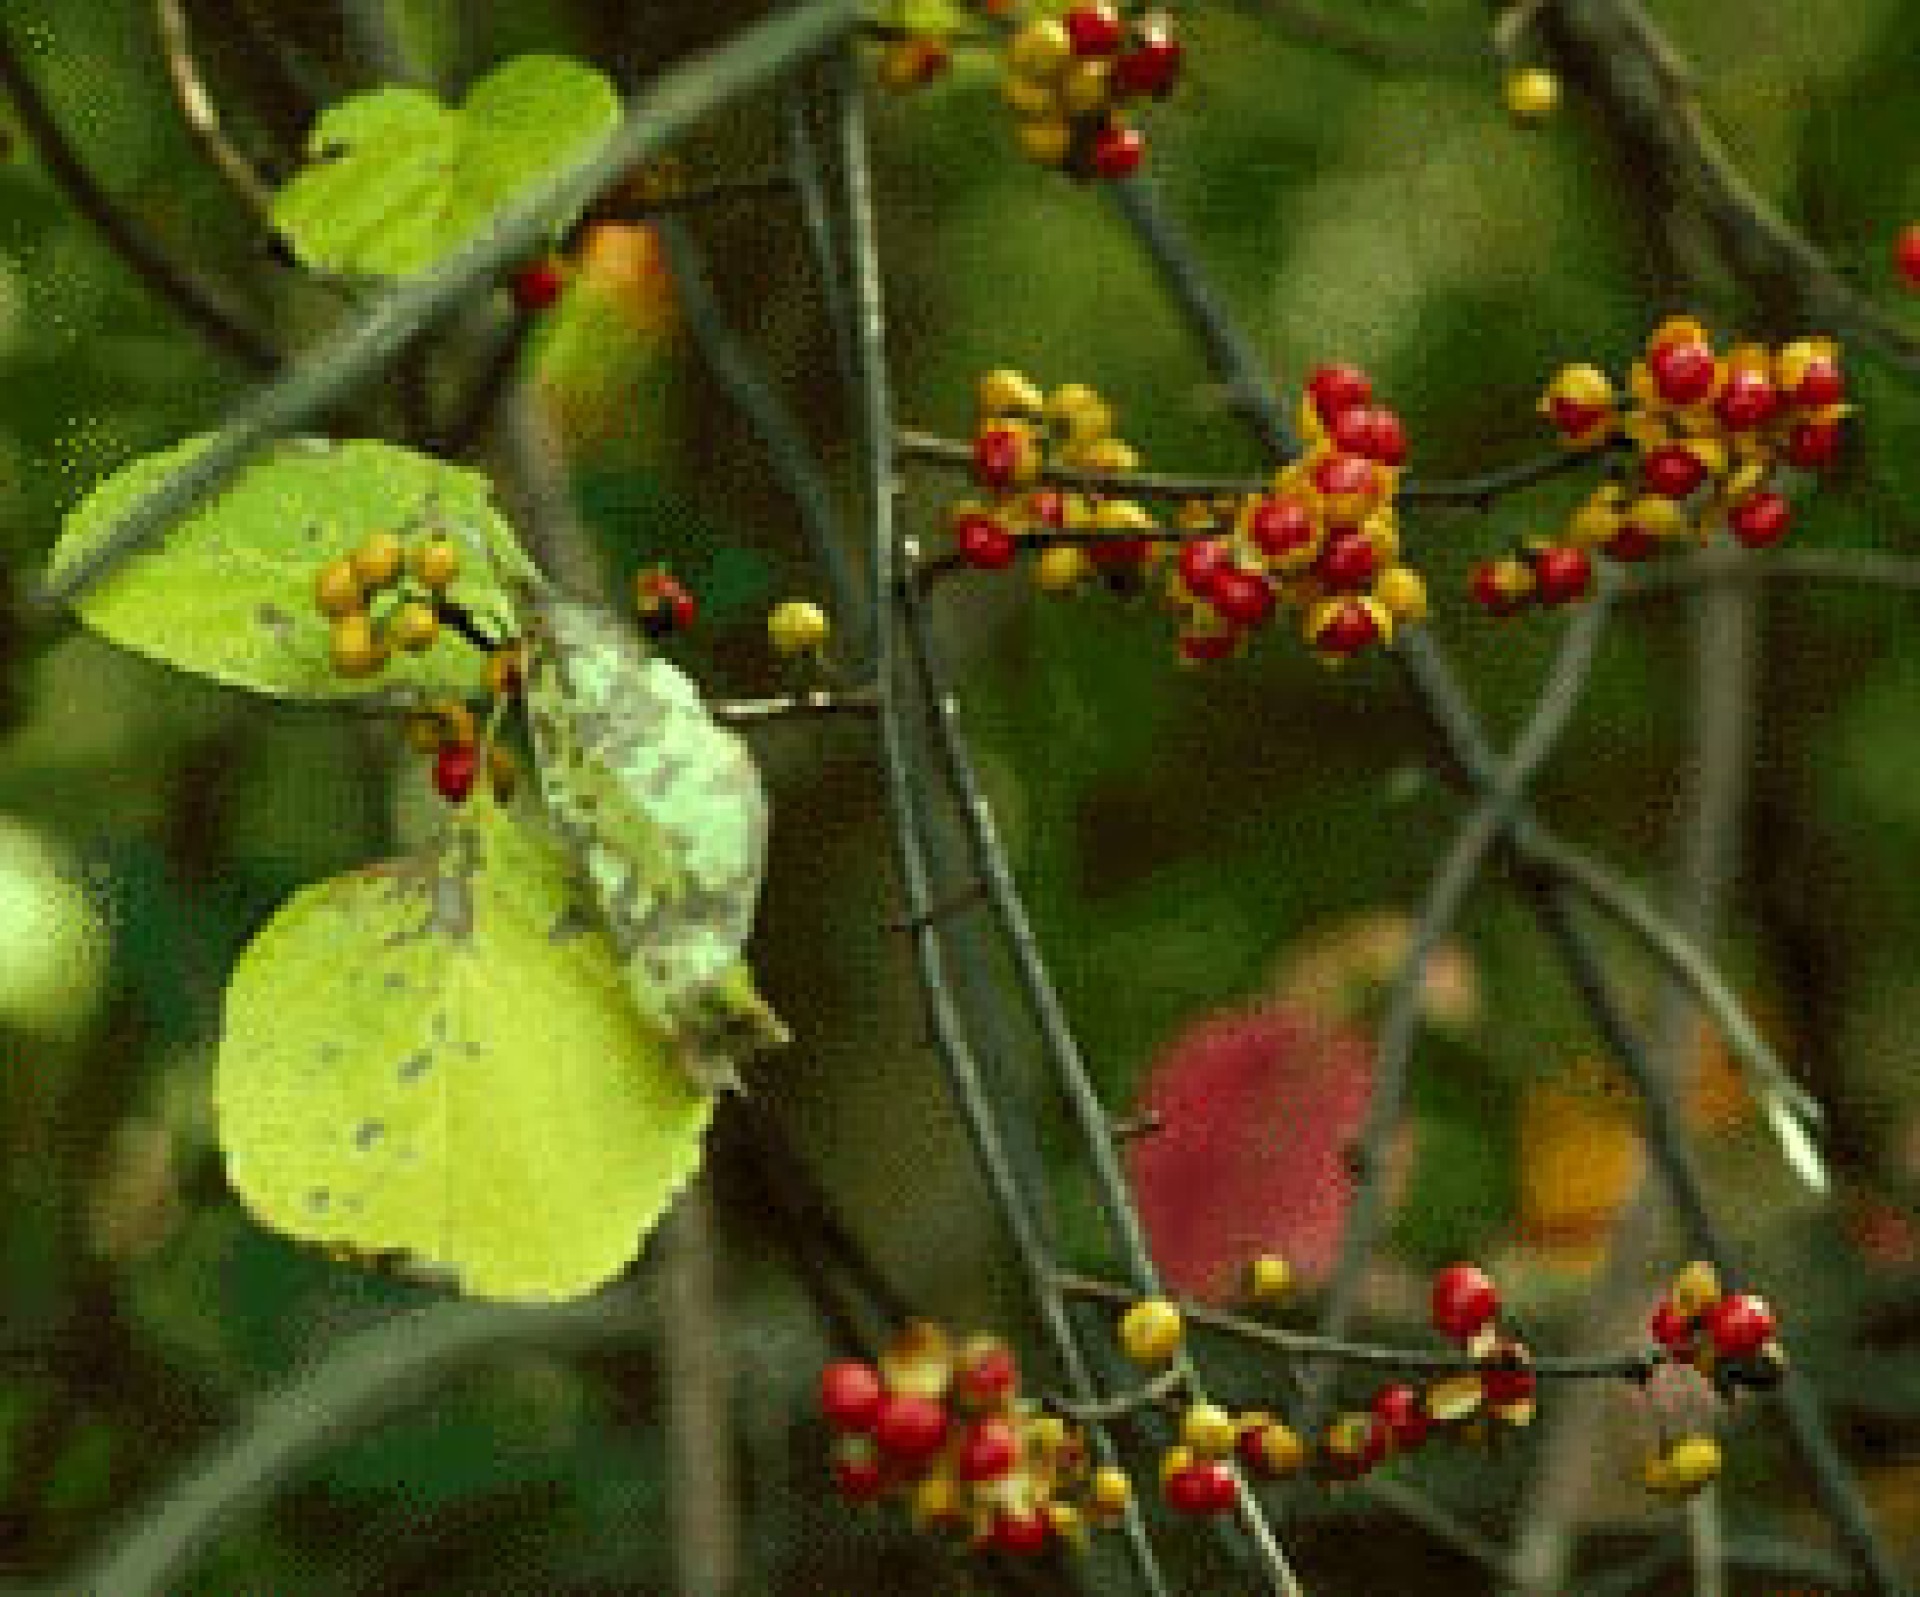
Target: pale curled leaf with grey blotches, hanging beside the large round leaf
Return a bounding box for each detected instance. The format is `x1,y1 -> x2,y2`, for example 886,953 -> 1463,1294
522,587 -> 787,1085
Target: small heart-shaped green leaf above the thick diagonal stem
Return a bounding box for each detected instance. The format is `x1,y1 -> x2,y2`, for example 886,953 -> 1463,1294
273,56 -> 620,276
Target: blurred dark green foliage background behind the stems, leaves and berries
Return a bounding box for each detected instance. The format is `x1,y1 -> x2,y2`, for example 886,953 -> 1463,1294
0,0 -> 1920,1593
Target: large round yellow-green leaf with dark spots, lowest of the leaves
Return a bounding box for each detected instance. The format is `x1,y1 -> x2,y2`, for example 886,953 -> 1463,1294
215,793 -> 712,1299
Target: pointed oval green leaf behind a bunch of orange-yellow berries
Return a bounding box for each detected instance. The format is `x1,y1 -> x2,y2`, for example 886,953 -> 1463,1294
48,438 -> 532,699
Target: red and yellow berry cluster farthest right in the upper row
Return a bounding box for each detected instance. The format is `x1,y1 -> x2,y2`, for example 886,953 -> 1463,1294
1473,317 -> 1849,616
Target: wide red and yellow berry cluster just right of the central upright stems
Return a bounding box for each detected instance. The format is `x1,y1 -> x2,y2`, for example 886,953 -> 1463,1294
948,365 -> 1427,662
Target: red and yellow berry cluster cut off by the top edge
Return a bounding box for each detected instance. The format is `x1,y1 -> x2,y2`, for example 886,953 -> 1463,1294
1002,0 -> 1183,179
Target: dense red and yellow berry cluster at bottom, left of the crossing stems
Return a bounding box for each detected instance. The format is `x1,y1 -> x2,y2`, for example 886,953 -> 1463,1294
820,1321 -> 1133,1555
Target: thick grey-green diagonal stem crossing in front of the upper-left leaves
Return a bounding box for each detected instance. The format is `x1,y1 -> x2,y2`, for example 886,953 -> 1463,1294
28,0 -> 858,608
